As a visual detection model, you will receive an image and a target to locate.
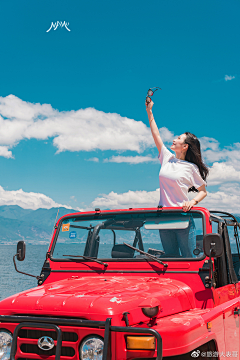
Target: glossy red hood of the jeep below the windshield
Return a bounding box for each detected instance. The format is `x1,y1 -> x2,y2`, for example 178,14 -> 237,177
0,276 -> 196,325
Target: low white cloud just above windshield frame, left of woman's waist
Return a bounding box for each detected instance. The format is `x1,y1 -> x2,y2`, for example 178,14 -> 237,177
91,189 -> 160,209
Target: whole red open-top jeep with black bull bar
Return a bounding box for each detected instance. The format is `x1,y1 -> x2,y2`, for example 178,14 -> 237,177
0,207 -> 240,360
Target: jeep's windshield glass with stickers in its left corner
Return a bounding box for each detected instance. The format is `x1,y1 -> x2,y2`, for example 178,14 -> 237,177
51,212 -> 204,260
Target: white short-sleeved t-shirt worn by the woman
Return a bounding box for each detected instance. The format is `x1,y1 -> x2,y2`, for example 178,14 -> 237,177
158,145 -> 206,206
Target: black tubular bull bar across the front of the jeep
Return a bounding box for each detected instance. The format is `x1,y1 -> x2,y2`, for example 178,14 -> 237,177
0,315 -> 162,360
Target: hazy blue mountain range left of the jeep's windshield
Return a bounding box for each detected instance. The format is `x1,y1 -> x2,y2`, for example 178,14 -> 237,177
0,205 -> 78,244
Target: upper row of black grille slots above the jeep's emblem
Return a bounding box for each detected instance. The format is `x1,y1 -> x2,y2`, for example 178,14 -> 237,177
18,329 -> 78,342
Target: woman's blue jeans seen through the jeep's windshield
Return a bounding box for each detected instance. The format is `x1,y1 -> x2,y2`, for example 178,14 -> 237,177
159,216 -> 196,258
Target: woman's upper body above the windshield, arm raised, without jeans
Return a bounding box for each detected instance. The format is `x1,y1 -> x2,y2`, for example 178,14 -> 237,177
146,100 -> 209,211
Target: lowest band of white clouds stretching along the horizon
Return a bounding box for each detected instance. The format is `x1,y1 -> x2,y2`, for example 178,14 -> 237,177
0,183 -> 240,214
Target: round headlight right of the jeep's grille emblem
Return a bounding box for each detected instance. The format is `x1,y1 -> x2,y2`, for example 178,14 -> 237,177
79,336 -> 104,360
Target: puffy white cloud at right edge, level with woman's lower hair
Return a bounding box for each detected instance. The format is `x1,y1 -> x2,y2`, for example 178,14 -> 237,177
207,162 -> 240,185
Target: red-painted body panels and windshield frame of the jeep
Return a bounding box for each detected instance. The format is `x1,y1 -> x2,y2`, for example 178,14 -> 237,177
0,207 -> 240,360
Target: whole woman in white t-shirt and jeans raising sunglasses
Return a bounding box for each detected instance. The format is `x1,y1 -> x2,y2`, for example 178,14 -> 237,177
146,101 -> 209,257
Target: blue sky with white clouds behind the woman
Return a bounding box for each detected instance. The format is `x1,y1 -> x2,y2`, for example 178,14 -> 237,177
0,0 -> 240,210
